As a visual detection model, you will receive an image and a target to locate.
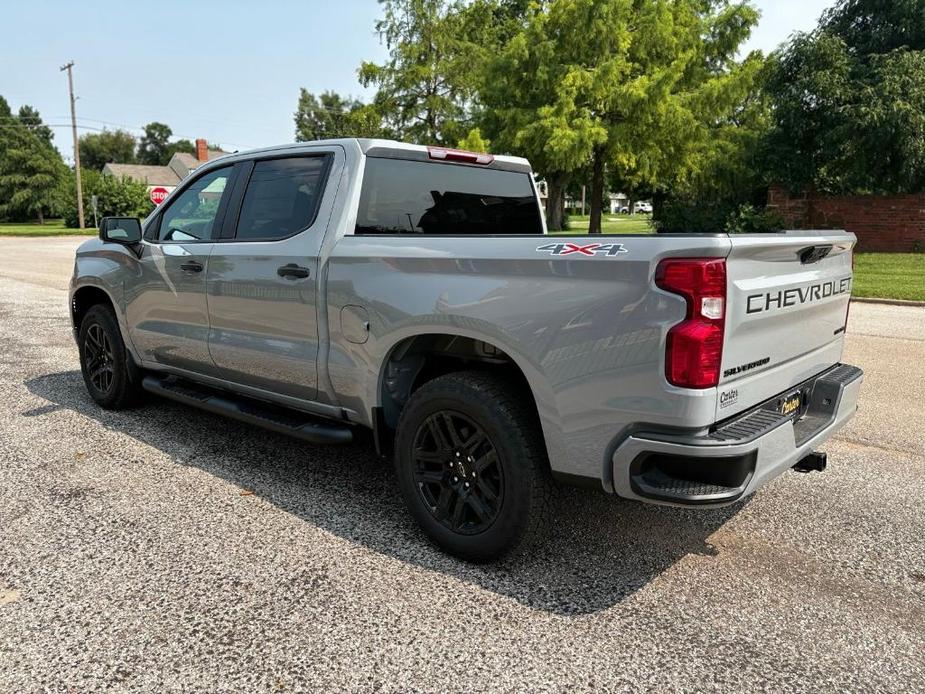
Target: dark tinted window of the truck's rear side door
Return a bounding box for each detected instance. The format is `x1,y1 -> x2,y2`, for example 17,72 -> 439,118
235,156 -> 328,241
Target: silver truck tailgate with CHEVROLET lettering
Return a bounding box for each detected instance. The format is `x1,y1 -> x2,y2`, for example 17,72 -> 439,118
716,231 -> 857,420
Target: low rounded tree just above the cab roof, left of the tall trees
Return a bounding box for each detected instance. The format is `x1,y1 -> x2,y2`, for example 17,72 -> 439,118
295,87 -> 382,142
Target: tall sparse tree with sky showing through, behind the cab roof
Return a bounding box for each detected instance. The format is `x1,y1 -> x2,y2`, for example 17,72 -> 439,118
359,0 -> 485,144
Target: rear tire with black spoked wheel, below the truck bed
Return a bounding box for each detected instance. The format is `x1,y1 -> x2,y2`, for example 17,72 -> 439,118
395,371 -> 554,562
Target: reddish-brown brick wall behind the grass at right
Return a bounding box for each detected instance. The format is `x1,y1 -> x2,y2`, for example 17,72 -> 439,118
768,186 -> 925,253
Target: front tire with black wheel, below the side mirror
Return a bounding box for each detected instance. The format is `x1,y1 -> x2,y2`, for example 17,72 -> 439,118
77,304 -> 143,410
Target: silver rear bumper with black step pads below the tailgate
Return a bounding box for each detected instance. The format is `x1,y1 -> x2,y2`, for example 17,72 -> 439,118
612,364 -> 863,506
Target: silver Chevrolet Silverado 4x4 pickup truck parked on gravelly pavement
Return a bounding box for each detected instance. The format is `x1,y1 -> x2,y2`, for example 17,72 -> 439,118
70,139 -> 862,561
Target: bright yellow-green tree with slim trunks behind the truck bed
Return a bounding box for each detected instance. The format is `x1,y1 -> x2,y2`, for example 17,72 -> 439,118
482,0 -> 760,233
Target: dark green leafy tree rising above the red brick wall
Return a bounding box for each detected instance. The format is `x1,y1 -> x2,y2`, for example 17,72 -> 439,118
765,0 -> 925,193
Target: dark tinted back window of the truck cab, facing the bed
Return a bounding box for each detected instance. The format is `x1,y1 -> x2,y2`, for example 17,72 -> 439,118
356,157 -> 543,236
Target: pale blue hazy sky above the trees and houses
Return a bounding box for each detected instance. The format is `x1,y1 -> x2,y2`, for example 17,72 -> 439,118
0,0 -> 833,158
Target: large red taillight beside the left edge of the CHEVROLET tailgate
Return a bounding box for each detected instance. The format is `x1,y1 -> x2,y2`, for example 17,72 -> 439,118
655,258 -> 726,388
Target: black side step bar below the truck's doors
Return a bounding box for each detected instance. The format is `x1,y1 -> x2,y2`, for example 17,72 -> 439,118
141,376 -> 353,443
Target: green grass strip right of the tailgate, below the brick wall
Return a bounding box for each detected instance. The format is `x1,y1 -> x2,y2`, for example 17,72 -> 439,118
851,253 -> 925,301
